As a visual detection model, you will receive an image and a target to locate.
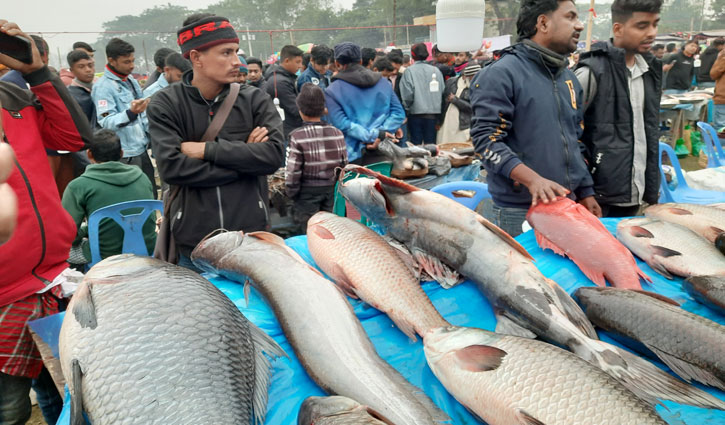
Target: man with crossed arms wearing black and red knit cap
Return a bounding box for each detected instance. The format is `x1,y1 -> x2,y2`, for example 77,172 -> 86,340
148,14 -> 284,269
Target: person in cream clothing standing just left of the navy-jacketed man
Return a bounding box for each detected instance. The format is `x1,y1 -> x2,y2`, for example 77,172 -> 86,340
437,64 -> 481,144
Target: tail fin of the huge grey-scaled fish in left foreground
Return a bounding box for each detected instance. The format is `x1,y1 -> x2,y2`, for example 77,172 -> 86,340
247,321 -> 289,425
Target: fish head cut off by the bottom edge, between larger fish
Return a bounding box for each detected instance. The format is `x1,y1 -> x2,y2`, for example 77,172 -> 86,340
297,395 -> 393,425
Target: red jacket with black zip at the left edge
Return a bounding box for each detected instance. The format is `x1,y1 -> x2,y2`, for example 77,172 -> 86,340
0,67 -> 92,307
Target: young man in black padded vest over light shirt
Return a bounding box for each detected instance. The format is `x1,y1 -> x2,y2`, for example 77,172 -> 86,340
575,0 -> 662,217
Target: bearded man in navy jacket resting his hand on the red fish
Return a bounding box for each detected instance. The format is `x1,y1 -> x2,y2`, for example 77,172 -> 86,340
471,0 -> 601,236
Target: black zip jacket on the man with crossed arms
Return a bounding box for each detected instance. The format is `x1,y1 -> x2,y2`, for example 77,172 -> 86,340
147,71 -> 284,256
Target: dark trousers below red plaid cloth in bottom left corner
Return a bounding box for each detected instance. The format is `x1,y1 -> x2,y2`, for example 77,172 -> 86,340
0,367 -> 63,425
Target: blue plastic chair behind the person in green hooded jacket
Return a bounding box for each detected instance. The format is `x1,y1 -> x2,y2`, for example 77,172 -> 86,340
88,199 -> 164,268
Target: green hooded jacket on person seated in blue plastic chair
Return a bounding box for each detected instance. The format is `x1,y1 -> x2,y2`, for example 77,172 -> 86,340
62,161 -> 156,260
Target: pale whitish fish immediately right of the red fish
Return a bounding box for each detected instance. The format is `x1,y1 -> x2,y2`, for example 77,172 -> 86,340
617,217 -> 725,279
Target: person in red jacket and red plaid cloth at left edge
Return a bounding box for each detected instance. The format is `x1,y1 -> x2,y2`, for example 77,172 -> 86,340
0,19 -> 91,423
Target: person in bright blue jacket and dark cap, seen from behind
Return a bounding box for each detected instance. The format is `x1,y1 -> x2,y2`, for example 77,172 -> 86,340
325,42 -> 405,164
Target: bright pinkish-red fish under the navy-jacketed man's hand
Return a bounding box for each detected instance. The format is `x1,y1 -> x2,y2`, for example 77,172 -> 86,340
526,198 -> 651,289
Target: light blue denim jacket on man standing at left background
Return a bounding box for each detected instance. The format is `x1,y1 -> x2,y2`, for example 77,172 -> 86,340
91,68 -> 148,158
